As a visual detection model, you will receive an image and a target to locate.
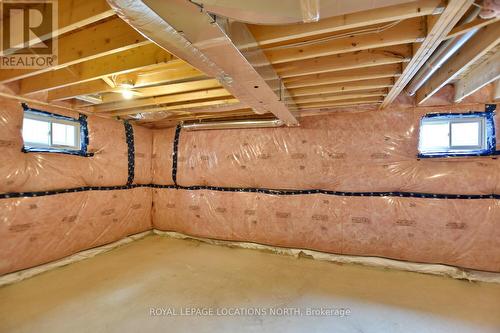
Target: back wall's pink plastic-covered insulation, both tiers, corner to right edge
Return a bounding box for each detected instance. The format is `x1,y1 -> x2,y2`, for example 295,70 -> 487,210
153,104 -> 500,272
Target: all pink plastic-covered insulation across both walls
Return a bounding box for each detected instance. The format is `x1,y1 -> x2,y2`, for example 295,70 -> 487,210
0,95 -> 500,274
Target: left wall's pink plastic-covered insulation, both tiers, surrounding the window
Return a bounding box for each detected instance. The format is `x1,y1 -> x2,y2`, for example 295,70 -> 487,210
0,98 -> 152,274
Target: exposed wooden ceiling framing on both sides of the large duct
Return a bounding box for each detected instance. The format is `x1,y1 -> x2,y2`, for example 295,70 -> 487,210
0,0 -> 484,124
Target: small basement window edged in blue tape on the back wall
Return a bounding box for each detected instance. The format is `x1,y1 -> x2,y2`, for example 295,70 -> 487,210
418,111 -> 496,157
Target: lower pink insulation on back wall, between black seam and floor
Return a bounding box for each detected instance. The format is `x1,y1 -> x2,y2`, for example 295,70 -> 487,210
153,189 -> 500,272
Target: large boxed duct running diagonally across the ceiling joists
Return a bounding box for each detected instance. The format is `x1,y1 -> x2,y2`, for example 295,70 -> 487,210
107,0 -> 298,125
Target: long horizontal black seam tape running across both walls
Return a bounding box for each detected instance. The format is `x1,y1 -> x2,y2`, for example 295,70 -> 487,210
0,184 -> 500,200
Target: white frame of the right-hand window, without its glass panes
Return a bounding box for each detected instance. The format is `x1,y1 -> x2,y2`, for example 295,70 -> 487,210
418,116 -> 488,155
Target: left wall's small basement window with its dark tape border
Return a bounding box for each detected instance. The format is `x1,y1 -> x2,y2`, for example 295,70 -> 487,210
22,105 -> 87,156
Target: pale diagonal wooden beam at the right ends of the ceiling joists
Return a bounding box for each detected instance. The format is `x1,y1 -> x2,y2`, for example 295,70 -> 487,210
381,0 -> 474,108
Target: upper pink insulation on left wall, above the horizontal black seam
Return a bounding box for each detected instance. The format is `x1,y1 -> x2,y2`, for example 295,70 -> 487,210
0,99 -> 152,193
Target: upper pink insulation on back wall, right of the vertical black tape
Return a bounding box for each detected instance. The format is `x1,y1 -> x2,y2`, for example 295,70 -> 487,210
177,105 -> 500,194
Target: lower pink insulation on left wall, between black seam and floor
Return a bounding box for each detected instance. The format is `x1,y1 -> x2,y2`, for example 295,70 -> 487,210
0,188 -> 151,274
